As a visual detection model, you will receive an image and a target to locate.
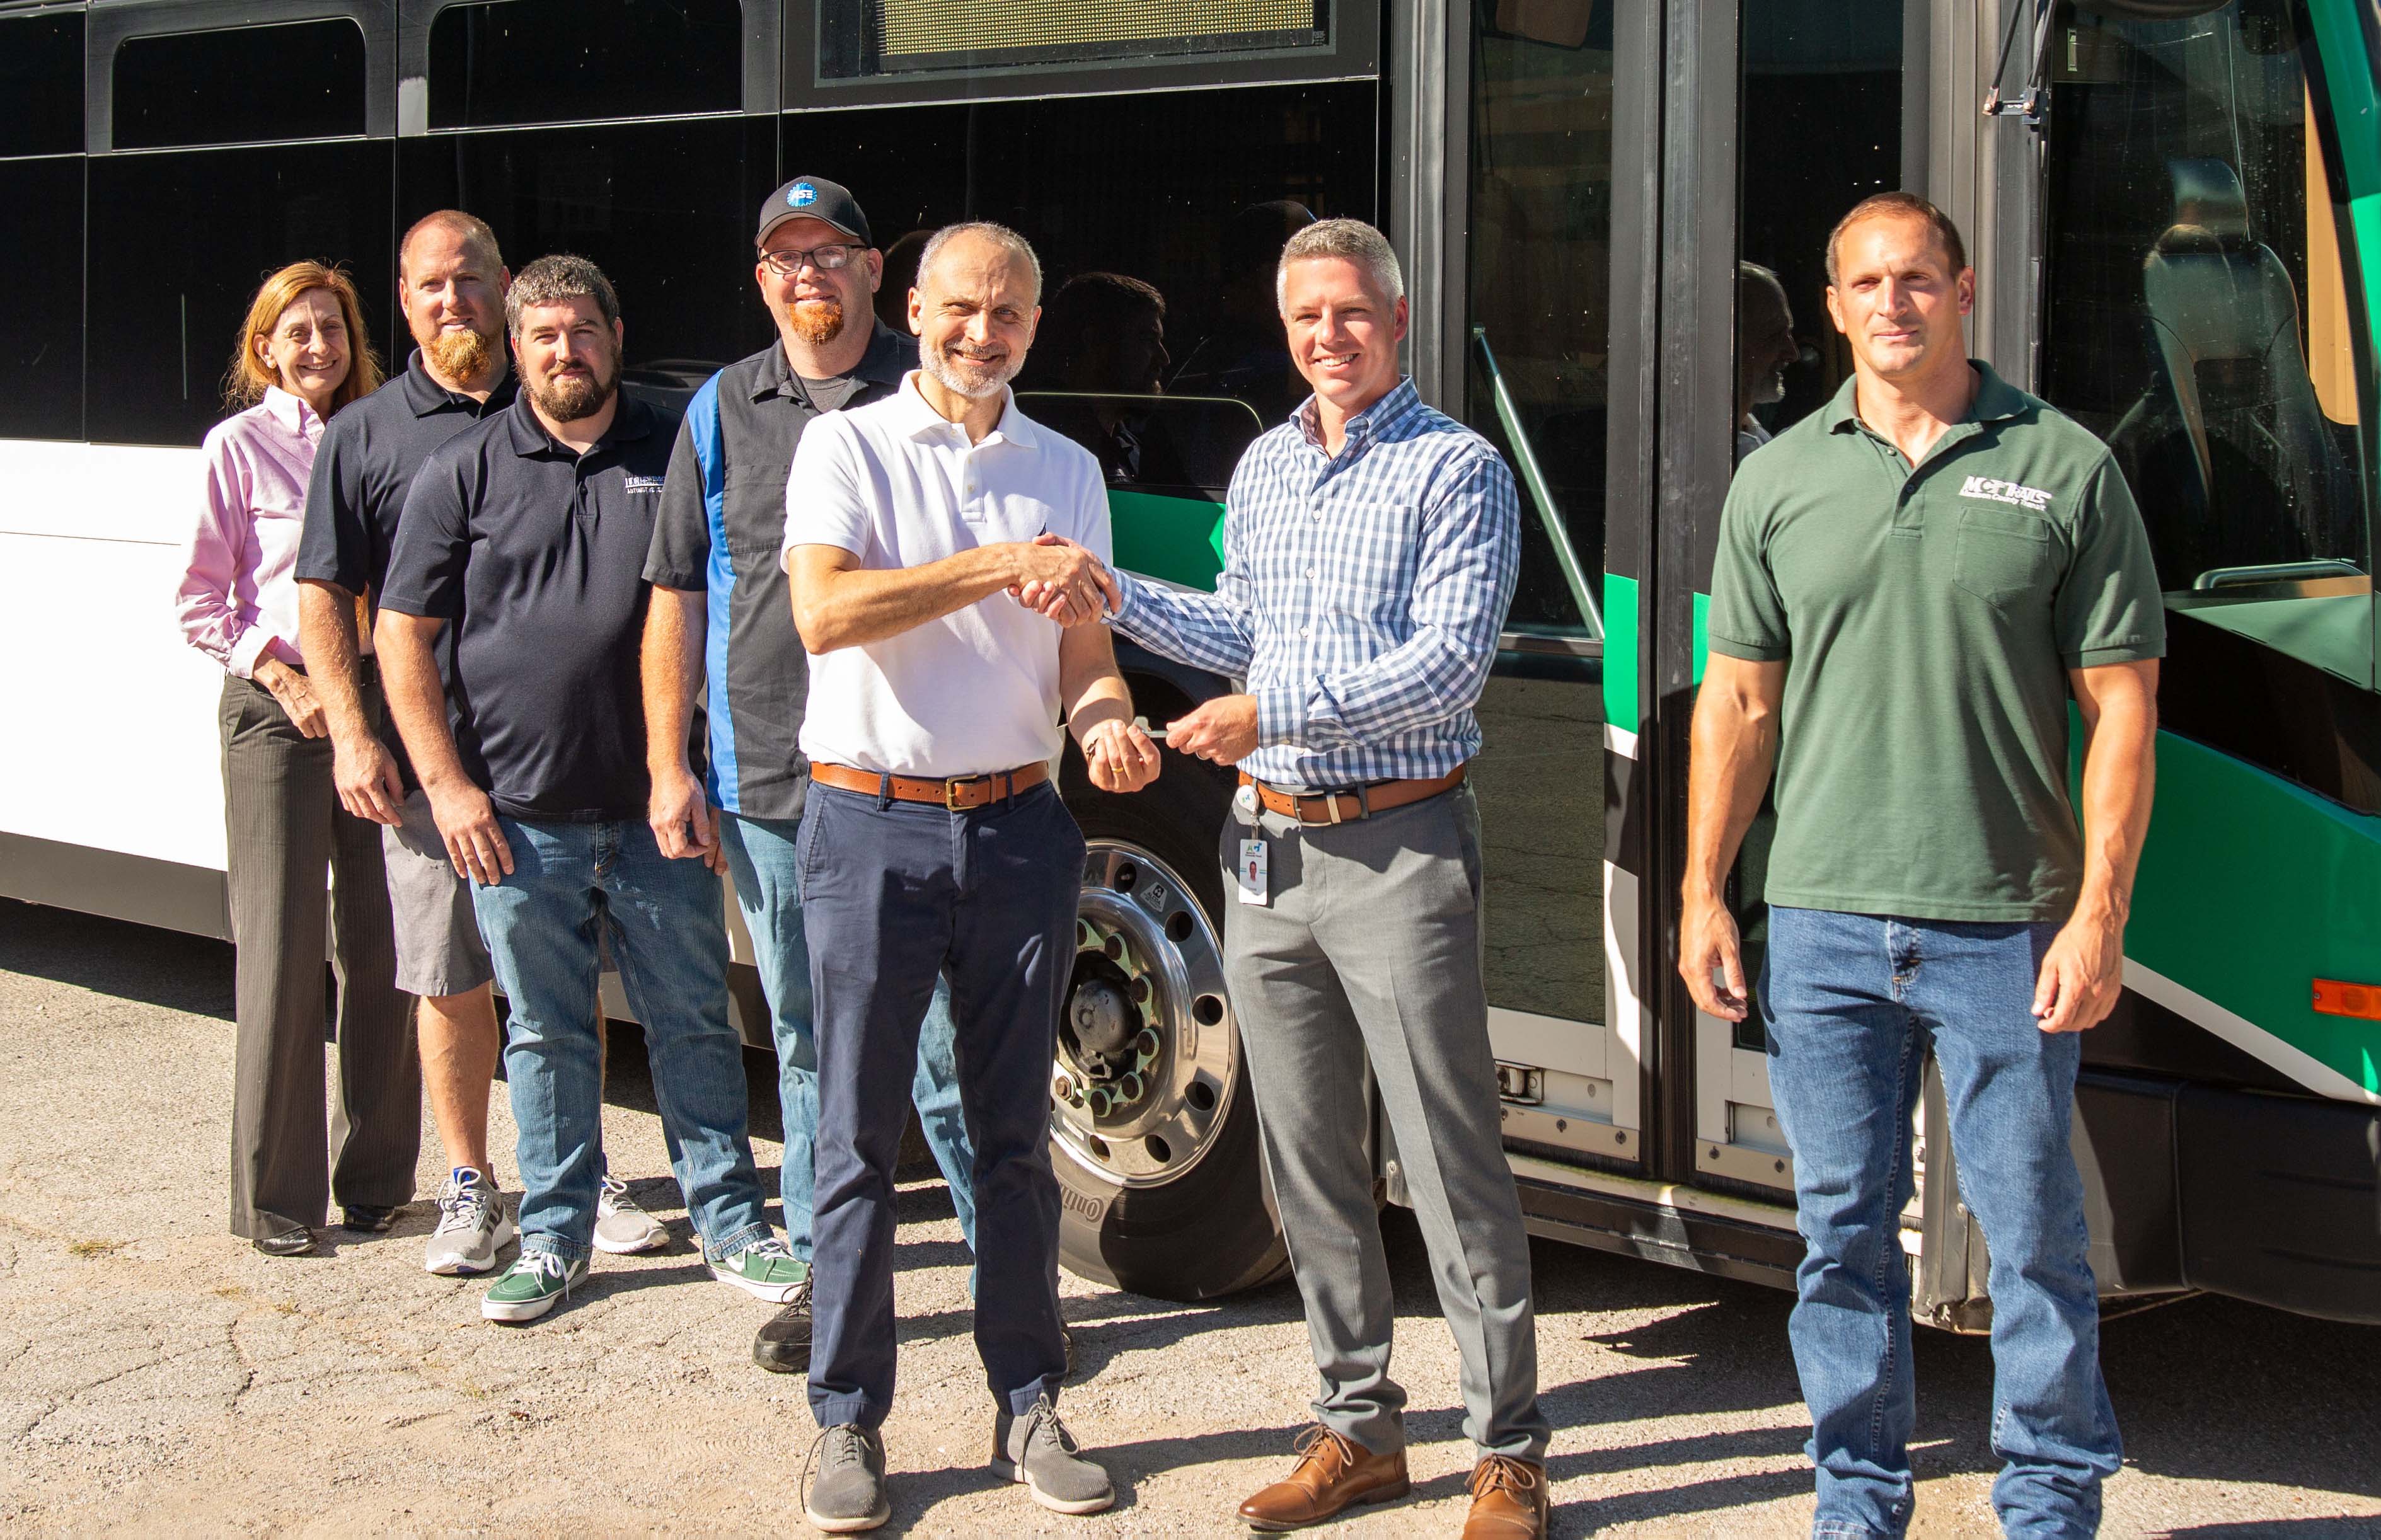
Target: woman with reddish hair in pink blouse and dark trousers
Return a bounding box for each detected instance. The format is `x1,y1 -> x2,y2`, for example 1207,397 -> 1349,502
174,262 -> 422,1256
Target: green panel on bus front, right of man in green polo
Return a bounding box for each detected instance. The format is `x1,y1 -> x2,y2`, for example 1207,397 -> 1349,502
2069,719 -> 2381,1093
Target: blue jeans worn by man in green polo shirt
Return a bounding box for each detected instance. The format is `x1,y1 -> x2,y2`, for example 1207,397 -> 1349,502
1760,909 -> 2121,1537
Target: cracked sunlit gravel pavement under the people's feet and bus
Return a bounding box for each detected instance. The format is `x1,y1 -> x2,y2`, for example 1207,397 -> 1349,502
0,902 -> 2381,1537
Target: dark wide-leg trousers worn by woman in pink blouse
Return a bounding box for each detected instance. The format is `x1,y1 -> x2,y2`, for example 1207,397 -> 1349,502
217,674 -> 422,1240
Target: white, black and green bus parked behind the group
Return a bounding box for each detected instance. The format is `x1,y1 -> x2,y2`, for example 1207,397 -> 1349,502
0,0 -> 2381,1328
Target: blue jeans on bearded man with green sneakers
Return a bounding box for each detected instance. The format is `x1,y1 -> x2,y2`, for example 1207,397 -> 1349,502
471,817 -> 769,1259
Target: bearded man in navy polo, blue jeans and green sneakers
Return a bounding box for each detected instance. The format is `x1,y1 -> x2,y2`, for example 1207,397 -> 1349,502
374,257 -> 805,1321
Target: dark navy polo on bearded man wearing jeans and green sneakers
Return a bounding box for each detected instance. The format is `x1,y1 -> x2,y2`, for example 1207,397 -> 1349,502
381,390 -> 679,824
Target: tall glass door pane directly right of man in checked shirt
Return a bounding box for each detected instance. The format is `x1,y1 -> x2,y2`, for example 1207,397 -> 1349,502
1443,0 -> 1612,1023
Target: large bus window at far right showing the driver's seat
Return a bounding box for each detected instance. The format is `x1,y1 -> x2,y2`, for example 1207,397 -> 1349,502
2043,0 -> 2374,686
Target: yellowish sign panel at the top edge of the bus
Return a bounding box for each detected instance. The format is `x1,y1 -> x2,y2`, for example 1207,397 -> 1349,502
819,0 -> 1331,81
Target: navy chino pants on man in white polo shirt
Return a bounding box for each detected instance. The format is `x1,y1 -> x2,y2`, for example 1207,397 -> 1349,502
795,783 -> 1083,1428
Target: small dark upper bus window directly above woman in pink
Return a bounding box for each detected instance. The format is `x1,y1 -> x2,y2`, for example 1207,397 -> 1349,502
112,16 -> 364,150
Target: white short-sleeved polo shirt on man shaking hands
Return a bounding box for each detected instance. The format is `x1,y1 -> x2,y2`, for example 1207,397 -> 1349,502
778,371 -> 1112,778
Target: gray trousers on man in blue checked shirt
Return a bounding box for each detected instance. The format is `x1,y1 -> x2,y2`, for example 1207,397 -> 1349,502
1217,786 -> 1548,1459
